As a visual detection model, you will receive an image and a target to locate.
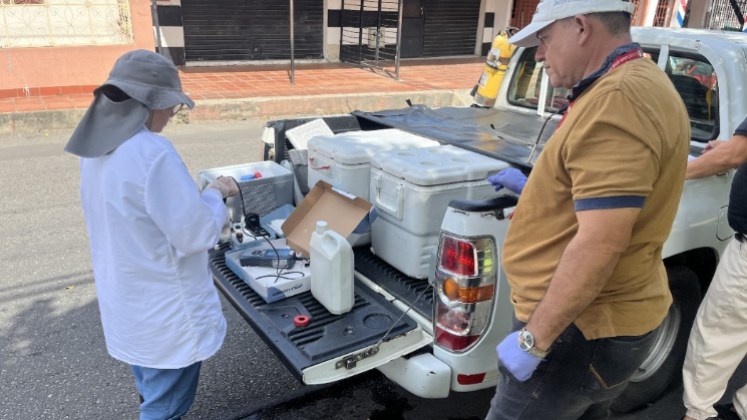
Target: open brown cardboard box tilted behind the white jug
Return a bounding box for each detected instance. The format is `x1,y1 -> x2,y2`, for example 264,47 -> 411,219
282,181 -> 373,258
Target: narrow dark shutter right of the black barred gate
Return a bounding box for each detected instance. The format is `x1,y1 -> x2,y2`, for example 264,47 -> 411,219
423,0 -> 480,57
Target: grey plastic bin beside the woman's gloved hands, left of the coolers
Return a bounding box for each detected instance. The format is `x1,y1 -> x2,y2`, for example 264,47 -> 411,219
198,161 -> 293,222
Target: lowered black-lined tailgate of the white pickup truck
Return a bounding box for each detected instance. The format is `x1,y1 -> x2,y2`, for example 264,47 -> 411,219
210,245 -> 433,385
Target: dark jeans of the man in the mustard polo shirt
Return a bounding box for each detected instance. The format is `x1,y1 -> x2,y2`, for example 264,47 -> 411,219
487,319 -> 655,420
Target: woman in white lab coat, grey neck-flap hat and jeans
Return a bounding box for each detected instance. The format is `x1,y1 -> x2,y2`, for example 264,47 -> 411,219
65,50 -> 238,420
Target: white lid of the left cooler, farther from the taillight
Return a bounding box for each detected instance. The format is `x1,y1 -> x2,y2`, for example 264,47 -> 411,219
309,128 -> 440,165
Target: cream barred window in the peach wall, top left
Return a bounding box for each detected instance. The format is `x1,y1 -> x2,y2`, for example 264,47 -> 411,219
0,0 -> 133,48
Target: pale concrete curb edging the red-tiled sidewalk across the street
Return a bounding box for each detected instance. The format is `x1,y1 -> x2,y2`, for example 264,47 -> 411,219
0,89 -> 471,135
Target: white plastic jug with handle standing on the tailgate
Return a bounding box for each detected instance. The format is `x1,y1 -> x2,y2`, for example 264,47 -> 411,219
310,221 -> 355,315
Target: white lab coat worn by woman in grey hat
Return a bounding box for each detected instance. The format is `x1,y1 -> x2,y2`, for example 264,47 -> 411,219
80,128 -> 227,369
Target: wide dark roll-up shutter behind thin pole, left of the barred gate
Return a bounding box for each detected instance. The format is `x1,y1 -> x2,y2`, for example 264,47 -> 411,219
182,0 -> 324,61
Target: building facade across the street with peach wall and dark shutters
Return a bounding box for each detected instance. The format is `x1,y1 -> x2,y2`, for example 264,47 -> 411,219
0,0 -> 736,91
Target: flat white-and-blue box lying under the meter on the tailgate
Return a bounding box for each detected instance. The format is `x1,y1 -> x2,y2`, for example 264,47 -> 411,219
225,238 -> 311,303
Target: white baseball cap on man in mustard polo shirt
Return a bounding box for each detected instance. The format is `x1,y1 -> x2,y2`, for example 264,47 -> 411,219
508,0 -> 635,47
